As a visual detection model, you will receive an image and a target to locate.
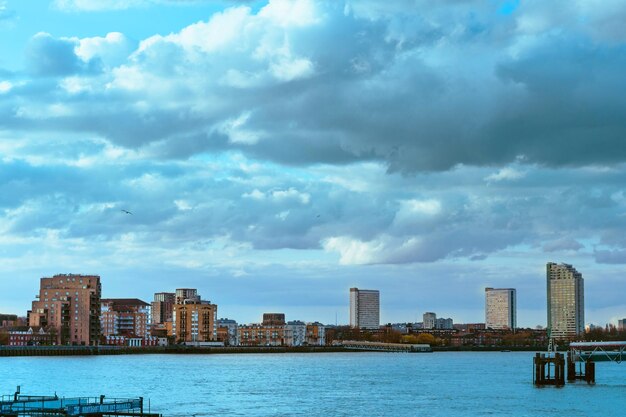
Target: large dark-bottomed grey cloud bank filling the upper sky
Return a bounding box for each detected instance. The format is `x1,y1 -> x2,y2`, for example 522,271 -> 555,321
9,0 -> 626,172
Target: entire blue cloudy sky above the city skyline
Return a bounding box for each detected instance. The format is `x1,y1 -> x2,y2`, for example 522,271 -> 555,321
0,0 -> 626,326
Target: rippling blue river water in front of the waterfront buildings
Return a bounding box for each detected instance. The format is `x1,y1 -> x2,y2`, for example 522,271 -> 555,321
0,352 -> 626,417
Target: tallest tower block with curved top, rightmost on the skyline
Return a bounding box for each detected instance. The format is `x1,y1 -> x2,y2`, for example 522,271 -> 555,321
546,262 -> 585,339
